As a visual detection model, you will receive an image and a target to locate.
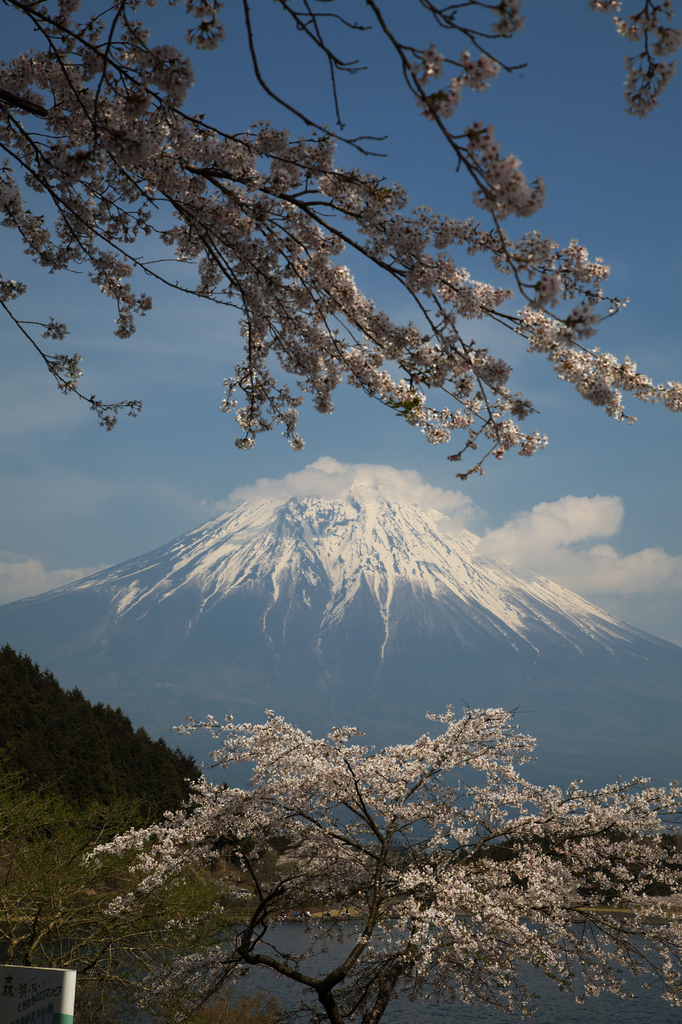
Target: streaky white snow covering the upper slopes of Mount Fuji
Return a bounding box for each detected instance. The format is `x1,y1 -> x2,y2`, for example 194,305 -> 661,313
66,492 -> 624,654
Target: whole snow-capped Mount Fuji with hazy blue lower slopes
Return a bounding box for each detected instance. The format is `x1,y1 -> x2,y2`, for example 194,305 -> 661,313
0,496 -> 682,784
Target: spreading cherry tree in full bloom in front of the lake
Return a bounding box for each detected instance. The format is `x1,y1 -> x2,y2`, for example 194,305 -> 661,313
95,708 -> 682,1024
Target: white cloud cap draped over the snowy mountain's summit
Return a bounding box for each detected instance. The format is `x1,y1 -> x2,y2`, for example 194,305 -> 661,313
222,457 -> 477,522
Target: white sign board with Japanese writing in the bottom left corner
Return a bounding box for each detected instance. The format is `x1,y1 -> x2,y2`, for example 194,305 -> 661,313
0,966 -> 76,1024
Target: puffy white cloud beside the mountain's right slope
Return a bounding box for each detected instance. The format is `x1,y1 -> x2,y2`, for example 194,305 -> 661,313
477,495 -> 682,596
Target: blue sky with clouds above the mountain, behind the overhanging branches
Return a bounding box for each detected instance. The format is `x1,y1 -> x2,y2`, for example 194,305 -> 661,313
0,0 -> 682,638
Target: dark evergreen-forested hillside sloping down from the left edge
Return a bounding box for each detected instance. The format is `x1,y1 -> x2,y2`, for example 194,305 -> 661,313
0,644 -> 201,817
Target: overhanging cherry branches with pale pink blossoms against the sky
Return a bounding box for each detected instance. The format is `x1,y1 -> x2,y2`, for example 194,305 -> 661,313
0,0 -> 682,478
